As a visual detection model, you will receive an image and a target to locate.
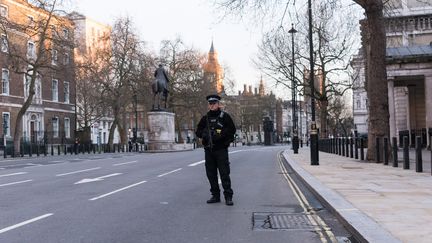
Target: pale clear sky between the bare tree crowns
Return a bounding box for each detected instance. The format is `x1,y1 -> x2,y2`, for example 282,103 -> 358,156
73,0 -> 264,96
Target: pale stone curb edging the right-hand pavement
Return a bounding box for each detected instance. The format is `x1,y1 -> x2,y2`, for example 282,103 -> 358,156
282,151 -> 401,242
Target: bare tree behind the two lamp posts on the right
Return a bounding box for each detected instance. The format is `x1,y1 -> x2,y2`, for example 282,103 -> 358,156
255,2 -> 357,137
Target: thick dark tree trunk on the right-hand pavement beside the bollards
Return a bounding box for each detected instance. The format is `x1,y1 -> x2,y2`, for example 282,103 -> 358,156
365,1 -> 390,160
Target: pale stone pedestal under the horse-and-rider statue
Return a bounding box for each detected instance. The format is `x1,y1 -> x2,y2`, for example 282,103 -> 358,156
147,111 -> 175,152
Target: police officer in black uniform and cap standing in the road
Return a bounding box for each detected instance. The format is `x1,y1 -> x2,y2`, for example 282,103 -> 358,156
195,95 -> 236,206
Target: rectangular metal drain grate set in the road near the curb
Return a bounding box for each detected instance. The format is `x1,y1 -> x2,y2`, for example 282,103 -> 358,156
253,213 -> 316,231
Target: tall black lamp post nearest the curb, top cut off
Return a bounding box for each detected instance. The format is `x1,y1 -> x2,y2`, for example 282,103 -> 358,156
308,0 -> 319,165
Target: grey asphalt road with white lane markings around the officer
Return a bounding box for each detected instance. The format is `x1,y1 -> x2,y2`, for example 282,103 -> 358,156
0,146 -> 349,243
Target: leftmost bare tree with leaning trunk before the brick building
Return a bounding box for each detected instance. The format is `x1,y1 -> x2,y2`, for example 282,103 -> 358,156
0,0 -> 73,153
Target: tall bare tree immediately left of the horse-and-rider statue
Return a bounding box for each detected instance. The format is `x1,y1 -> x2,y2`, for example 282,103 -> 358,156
94,17 -> 143,148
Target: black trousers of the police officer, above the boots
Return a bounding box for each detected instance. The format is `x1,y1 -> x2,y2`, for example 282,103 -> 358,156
205,148 -> 233,198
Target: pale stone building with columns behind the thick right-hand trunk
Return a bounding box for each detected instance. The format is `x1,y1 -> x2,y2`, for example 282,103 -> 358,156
353,0 -> 432,146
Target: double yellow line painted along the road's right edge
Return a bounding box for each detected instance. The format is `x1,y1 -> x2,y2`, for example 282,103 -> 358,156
278,152 -> 338,243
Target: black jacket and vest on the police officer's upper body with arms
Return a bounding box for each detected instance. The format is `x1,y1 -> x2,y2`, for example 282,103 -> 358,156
195,110 -> 236,150
